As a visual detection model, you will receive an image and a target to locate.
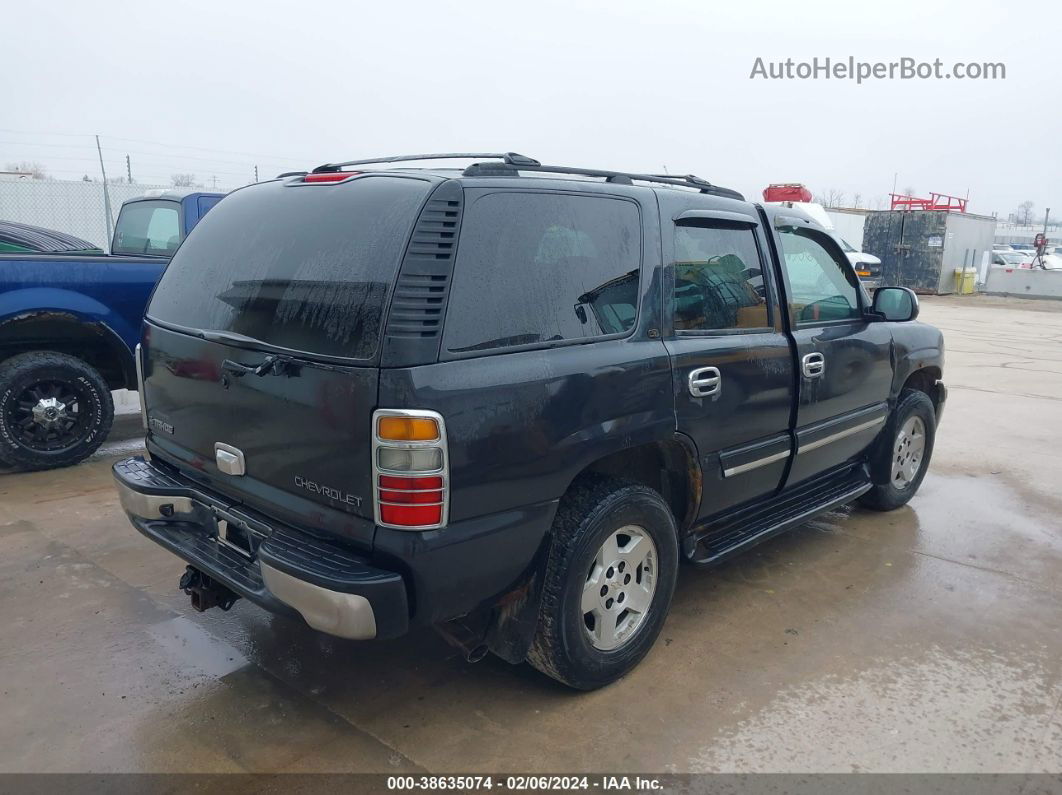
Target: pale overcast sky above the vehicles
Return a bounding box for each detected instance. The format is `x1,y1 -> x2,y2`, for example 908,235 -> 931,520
0,0 -> 1062,217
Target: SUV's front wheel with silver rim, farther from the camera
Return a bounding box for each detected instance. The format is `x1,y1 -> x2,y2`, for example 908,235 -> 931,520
859,390 -> 937,511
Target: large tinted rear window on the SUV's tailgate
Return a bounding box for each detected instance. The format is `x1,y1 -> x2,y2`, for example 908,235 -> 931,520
148,176 -> 430,359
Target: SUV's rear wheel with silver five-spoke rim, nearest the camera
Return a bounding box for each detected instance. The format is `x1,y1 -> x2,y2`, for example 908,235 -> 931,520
528,477 -> 679,690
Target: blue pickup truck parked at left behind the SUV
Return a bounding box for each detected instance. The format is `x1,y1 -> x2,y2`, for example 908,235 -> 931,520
0,191 -> 224,469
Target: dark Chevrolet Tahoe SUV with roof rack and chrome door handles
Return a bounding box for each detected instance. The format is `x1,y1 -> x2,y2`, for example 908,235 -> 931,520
114,153 -> 946,689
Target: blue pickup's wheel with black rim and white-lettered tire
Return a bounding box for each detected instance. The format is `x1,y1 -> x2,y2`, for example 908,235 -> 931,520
0,351 -> 115,469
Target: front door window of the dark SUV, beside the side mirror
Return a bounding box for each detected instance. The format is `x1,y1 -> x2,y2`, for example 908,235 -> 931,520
778,227 -> 860,324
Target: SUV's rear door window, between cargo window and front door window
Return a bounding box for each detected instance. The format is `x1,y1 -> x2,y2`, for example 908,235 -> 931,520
674,223 -> 770,331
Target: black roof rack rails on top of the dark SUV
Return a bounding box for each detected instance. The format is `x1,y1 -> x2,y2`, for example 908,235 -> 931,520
312,152 -> 744,201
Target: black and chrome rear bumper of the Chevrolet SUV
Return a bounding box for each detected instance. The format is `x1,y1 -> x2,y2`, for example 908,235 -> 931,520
114,456 -> 409,640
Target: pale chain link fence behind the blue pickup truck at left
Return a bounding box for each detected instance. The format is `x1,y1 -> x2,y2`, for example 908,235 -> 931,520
0,179 -> 176,250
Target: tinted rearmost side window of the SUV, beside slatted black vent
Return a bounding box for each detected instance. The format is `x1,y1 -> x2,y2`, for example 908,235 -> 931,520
445,192 -> 641,352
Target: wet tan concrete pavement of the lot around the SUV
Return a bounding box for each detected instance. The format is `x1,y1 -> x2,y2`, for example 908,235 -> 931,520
0,298 -> 1062,773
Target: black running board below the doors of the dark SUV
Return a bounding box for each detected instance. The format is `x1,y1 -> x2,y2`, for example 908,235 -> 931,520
683,466 -> 873,567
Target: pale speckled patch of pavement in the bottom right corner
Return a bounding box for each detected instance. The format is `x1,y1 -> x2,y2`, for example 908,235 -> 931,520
684,649 -> 1062,773
